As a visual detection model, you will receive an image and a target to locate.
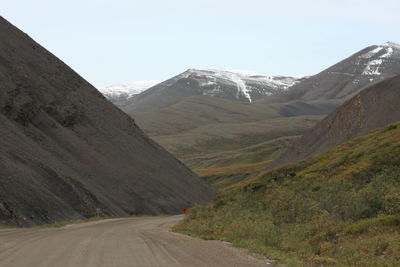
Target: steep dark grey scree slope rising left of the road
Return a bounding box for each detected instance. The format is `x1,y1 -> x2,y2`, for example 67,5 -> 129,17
0,18 -> 215,225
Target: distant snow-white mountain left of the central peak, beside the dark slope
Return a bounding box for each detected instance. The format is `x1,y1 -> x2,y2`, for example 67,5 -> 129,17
99,81 -> 162,102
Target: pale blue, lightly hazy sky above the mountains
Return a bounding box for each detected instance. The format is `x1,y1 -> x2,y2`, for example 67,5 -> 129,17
0,0 -> 400,88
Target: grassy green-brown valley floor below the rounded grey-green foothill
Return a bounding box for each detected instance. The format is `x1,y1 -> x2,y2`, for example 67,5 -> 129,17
152,116 -> 323,192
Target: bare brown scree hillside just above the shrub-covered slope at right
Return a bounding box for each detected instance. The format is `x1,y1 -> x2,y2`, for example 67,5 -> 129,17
271,75 -> 400,167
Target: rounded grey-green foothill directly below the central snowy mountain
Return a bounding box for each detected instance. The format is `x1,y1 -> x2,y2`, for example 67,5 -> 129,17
130,96 -> 280,136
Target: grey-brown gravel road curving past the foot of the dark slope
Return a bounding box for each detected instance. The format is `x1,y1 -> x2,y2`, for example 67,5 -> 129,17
0,216 -> 273,267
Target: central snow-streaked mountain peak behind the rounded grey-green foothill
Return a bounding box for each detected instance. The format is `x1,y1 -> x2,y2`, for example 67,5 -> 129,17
123,69 -> 302,114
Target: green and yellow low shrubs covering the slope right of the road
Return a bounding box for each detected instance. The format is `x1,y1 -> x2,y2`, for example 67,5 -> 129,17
175,123 -> 400,266
